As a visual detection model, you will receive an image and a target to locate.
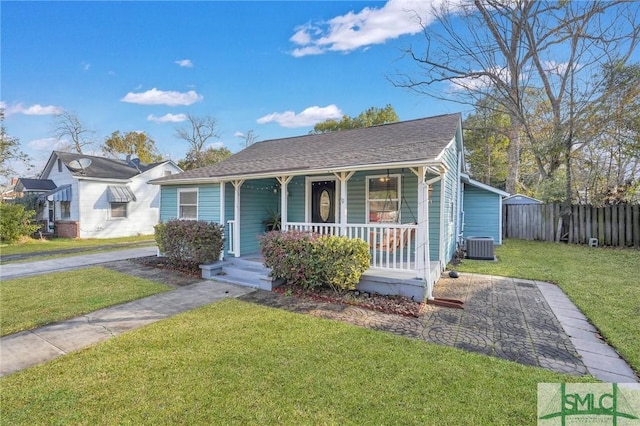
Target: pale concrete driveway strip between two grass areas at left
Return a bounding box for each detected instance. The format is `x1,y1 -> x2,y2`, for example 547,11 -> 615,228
0,246 -> 158,280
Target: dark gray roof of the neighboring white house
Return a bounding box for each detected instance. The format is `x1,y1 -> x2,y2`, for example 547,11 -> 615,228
55,151 -> 165,179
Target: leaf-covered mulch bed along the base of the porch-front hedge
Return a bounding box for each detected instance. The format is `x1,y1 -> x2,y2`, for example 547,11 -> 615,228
273,284 -> 423,318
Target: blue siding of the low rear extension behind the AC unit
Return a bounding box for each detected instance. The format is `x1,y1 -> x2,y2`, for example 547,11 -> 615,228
463,184 -> 502,244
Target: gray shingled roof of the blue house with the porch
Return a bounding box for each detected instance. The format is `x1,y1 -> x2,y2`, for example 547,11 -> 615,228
157,114 -> 461,183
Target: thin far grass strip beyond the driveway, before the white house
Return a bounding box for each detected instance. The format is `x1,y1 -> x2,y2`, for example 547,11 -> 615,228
0,235 -> 155,256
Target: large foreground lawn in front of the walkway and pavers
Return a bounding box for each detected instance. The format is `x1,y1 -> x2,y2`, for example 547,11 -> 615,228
0,299 -> 586,425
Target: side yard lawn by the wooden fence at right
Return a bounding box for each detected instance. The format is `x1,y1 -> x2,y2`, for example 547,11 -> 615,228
457,240 -> 640,371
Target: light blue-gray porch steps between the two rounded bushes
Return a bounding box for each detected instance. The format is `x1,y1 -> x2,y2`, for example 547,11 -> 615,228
200,258 -> 282,291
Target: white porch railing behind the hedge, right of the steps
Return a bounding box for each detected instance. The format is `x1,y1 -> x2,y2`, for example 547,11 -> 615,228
284,222 -> 418,271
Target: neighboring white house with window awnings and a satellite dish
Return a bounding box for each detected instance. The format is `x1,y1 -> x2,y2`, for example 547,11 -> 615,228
26,151 -> 182,238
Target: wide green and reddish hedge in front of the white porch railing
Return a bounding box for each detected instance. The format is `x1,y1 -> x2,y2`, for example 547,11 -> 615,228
260,231 -> 370,291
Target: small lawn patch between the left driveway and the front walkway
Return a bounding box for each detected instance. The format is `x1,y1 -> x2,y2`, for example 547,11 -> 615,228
0,267 -> 170,335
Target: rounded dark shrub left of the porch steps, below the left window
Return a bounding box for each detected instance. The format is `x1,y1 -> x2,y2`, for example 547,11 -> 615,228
154,220 -> 224,269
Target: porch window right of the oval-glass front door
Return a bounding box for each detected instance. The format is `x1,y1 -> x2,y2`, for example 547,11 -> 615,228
367,175 -> 400,223
